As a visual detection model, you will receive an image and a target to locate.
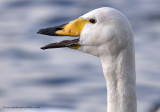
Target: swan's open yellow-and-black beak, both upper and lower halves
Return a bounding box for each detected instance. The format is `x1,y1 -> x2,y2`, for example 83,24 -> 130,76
37,18 -> 89,50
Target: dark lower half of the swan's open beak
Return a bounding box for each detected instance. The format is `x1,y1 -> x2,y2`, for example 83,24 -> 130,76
41,39 -> 79,50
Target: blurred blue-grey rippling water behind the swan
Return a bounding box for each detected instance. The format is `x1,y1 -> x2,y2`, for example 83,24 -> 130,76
0,0 -> 160,112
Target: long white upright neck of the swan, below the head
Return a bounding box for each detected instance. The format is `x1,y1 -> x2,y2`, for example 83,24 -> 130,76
101,50 -> 137,112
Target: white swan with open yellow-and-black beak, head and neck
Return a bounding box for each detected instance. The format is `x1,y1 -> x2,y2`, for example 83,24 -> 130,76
37,7 -> 137,112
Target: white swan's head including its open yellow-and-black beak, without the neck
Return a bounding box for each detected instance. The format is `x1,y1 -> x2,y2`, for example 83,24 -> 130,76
38,7 -> 133,57
